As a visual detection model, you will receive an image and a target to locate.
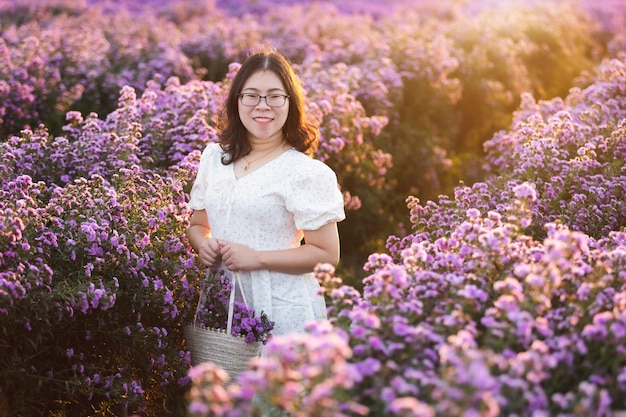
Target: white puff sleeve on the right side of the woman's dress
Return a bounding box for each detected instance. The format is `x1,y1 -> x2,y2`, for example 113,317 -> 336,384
286,157 -> 346,230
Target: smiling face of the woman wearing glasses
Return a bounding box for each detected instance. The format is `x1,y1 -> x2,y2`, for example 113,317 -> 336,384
238,70 -> 289,142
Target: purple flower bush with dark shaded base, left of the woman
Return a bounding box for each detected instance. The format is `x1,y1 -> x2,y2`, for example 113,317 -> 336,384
0,96 -> 200,415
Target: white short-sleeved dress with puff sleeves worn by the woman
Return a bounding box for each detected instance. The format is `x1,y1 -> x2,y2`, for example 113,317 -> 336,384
189,143 -> 345,335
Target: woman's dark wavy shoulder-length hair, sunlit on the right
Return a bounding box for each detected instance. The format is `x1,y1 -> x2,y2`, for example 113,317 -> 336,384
217,49 -> 319,165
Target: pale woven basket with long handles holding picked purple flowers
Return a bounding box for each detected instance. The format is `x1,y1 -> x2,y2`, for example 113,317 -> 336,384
183,272 -> 263,381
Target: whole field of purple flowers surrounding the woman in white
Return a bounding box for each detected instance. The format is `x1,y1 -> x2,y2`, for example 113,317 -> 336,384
0,0 -> 626,417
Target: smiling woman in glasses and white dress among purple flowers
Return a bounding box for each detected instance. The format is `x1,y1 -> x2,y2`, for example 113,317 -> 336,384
188,50 -> 345,334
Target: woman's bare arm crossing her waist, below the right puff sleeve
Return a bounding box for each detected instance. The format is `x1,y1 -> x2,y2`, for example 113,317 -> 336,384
219,222 -> 339,275
